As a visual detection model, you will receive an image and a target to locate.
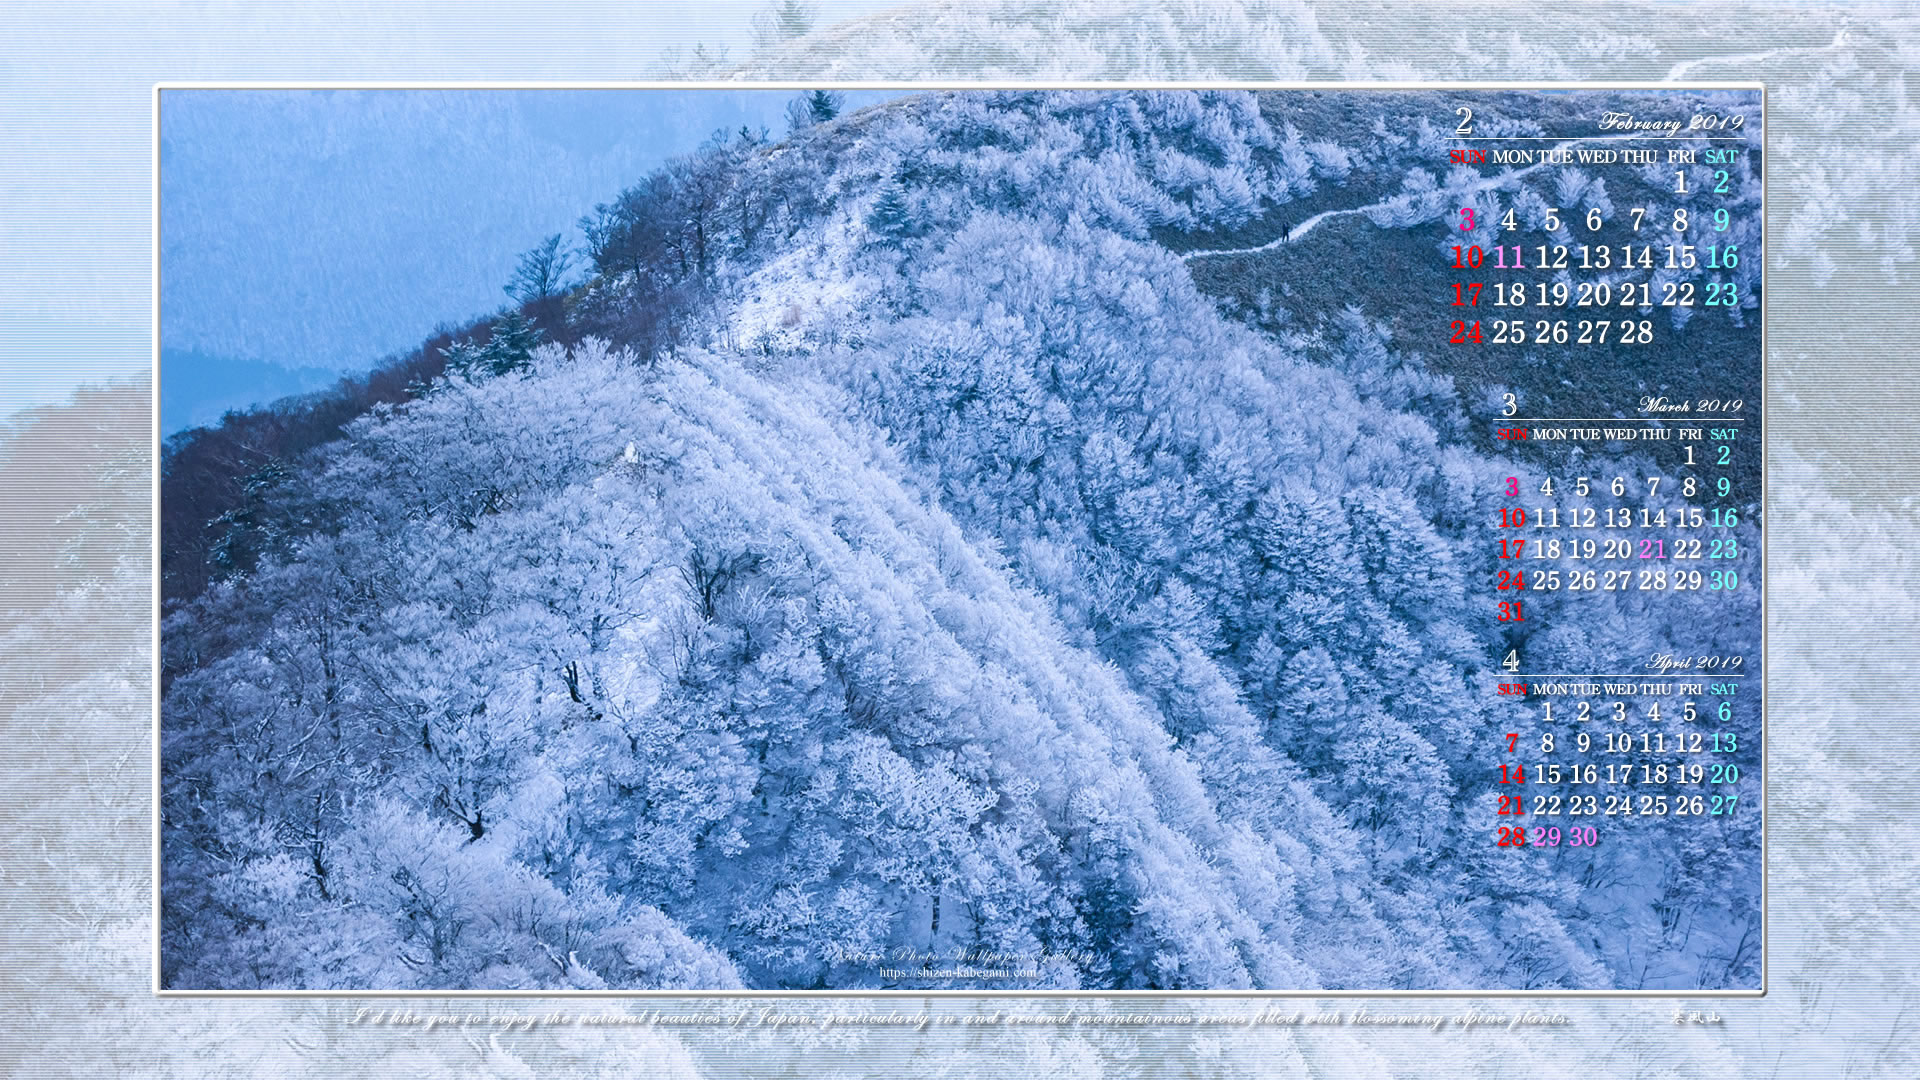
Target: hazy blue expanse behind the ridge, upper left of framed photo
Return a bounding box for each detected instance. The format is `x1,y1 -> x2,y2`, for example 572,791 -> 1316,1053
159,90 -> 875,430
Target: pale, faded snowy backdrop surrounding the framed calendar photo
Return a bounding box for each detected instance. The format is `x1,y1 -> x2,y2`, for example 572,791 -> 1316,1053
0,0 -> 1920,1078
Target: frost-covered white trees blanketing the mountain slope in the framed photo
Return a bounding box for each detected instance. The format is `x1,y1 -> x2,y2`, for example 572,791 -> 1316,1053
163,92 -> 1757,990
